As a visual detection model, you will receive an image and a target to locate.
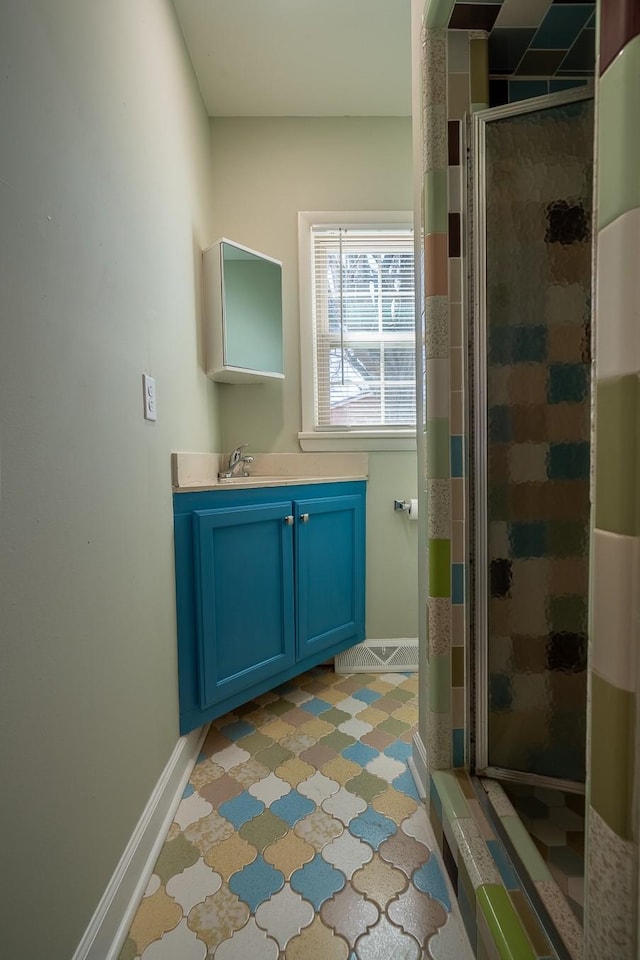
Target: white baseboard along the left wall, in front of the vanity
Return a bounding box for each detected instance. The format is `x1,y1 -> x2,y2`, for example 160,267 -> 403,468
72,725 -> 208,960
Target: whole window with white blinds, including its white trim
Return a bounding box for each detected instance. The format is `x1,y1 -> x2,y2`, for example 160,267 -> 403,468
300,213 -> 416,449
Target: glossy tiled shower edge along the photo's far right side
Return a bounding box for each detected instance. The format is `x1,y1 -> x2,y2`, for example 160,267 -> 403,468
585,0 -> 640,960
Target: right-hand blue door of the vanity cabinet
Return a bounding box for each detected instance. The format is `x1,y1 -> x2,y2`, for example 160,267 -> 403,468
294,496 -> 364,660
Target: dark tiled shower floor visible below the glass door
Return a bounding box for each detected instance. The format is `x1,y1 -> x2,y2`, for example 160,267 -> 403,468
503,784 -> 584,923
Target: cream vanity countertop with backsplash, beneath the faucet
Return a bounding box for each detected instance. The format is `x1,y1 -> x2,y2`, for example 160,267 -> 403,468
171,449 -> 369,493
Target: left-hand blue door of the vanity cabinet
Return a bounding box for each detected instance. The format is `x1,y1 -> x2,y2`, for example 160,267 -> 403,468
193,501 -> 295,709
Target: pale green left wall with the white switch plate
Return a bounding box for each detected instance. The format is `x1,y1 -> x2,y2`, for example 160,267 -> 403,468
0,0 -> 218,960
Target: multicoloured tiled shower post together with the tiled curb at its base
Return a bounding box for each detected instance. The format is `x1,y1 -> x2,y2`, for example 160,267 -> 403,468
421,13 -> 549,960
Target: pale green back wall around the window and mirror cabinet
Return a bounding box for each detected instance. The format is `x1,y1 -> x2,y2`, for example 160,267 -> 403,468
211,117 -> 418,639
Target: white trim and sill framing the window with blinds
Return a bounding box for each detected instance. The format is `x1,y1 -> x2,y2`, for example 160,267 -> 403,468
298,210 -> 416,452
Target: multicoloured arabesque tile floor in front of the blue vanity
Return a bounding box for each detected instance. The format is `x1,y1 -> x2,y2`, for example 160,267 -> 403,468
120,667 -> 472,960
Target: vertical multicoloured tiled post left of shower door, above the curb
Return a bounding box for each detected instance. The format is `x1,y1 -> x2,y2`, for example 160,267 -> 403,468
424,27 -> 489,770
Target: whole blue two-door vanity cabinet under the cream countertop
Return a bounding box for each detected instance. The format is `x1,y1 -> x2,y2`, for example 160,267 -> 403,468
174,481 -> 366,733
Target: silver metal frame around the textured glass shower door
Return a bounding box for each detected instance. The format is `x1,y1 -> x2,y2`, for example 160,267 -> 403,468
466,81 -> 593,793
